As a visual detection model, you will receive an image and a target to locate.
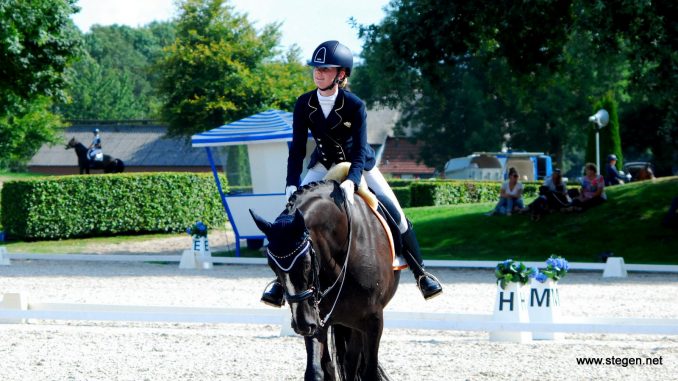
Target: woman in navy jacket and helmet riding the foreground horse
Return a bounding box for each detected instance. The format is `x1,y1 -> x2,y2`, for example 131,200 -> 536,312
261,41 -> 443,307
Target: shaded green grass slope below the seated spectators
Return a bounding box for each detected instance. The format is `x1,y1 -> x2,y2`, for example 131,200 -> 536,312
406,177 -> 678,264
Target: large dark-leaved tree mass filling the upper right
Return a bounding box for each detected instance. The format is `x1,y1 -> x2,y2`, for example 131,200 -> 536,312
355,0 -> 678,172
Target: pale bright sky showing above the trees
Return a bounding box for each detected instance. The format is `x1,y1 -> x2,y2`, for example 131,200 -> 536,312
72,0 -> 389,60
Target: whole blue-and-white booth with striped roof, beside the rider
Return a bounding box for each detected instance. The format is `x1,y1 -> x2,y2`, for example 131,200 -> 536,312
191,110 -> 315,255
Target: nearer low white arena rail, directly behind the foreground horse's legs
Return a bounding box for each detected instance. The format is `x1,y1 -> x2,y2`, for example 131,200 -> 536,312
0,294 -> 678,335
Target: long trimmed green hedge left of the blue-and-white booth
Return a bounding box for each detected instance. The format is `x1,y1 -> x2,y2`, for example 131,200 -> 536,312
1,173 -> 227,240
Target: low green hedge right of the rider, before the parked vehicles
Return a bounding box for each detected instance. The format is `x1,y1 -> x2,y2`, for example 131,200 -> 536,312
410,180 -> 540,207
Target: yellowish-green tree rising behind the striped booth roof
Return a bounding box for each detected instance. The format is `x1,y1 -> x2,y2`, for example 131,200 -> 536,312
157,0 -> 308,135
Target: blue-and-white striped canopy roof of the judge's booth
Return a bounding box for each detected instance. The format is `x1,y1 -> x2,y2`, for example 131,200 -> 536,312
191,110 -> 292,147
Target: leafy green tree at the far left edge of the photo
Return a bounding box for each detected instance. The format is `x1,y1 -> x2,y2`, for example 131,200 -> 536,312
0,0 -> 80,167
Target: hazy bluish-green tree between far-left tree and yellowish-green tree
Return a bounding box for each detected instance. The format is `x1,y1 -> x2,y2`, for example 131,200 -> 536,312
60,22 -> 174,120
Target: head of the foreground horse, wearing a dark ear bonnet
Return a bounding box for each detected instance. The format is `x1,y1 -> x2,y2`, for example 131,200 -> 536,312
250,209 -> 320,336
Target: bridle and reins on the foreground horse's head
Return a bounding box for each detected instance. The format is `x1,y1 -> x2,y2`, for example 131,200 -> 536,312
266,196 -> 352,327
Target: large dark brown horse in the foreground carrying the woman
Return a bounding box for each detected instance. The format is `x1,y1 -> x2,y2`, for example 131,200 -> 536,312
250,181 -> 400,380
